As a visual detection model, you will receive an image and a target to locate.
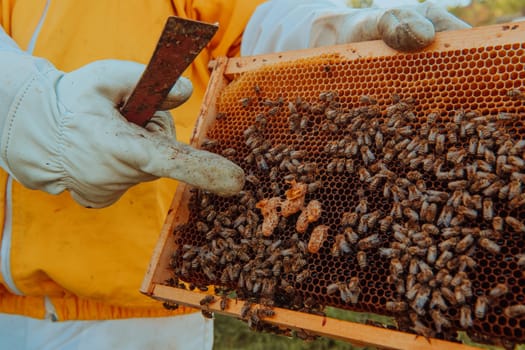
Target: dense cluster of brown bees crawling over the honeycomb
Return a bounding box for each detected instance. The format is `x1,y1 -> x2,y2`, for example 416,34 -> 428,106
172,87 -> 525,346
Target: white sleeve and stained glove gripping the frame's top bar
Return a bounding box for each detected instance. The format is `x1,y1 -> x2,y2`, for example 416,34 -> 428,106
241,0 -> 470,56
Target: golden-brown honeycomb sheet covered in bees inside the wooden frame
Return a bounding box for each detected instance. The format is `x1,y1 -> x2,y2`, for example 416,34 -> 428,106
171,43 -> 525,343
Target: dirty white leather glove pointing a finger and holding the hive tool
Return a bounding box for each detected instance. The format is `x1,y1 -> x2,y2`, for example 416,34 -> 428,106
0,28 -> 244,208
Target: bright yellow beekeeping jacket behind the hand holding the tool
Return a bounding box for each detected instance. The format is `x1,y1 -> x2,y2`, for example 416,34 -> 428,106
0,0 -> 262,320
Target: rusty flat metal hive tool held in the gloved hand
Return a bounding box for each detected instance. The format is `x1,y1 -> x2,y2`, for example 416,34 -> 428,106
121,16 -> 219,126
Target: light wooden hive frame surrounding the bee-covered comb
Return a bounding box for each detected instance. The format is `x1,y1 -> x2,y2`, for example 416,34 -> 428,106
141,22 -> 525,349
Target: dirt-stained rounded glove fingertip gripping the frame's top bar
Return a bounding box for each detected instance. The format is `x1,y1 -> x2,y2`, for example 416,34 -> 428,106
378,8 -> 435,51
